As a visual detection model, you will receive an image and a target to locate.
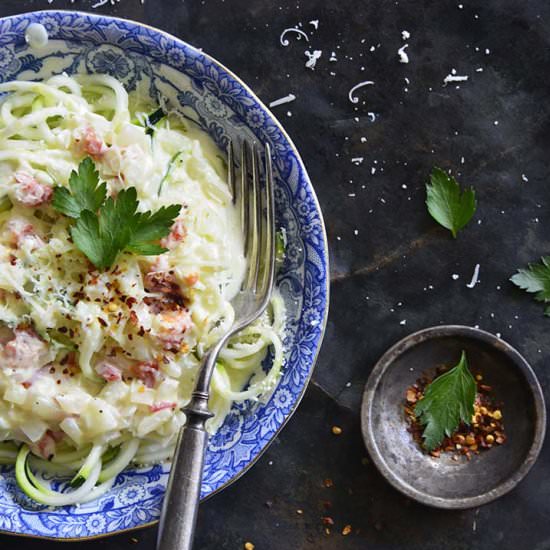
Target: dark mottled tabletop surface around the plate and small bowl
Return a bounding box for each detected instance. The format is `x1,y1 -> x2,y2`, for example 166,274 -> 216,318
0,0 -> 550,550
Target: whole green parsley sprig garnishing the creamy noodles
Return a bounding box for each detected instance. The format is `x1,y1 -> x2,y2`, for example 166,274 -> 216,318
52,158 -> 181,269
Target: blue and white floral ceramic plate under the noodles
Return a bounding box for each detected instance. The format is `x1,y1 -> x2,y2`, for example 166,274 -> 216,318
0,11 -> 328,539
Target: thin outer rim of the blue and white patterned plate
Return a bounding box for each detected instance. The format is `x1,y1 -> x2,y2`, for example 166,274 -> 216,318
0,8 -> 330,543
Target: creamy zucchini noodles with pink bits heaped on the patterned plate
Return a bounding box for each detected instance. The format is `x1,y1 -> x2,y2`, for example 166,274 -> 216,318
0,74 -> 285,506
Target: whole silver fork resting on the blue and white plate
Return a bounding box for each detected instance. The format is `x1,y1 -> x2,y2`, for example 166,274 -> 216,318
157,141 -> 275,550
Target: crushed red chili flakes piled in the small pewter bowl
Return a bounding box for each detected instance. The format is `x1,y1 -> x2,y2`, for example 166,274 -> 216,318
404,368 -> 506,460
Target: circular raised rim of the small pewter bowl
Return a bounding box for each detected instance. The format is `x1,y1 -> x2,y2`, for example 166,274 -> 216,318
361,325 -> 546,510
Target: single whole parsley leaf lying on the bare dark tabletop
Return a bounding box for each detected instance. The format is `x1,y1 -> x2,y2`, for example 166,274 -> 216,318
426,167 -> 477,238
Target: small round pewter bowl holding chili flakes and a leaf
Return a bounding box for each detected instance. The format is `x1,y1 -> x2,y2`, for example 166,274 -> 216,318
361,325 -> 546,509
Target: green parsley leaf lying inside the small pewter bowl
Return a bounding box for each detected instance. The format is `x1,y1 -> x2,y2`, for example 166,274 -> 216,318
414,351 -> 477,451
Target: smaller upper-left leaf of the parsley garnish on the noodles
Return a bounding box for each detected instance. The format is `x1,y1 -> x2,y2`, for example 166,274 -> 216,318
52,157 -> 107,219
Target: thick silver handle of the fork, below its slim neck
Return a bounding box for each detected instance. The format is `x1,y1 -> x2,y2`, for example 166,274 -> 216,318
157,392 -> 216,550
